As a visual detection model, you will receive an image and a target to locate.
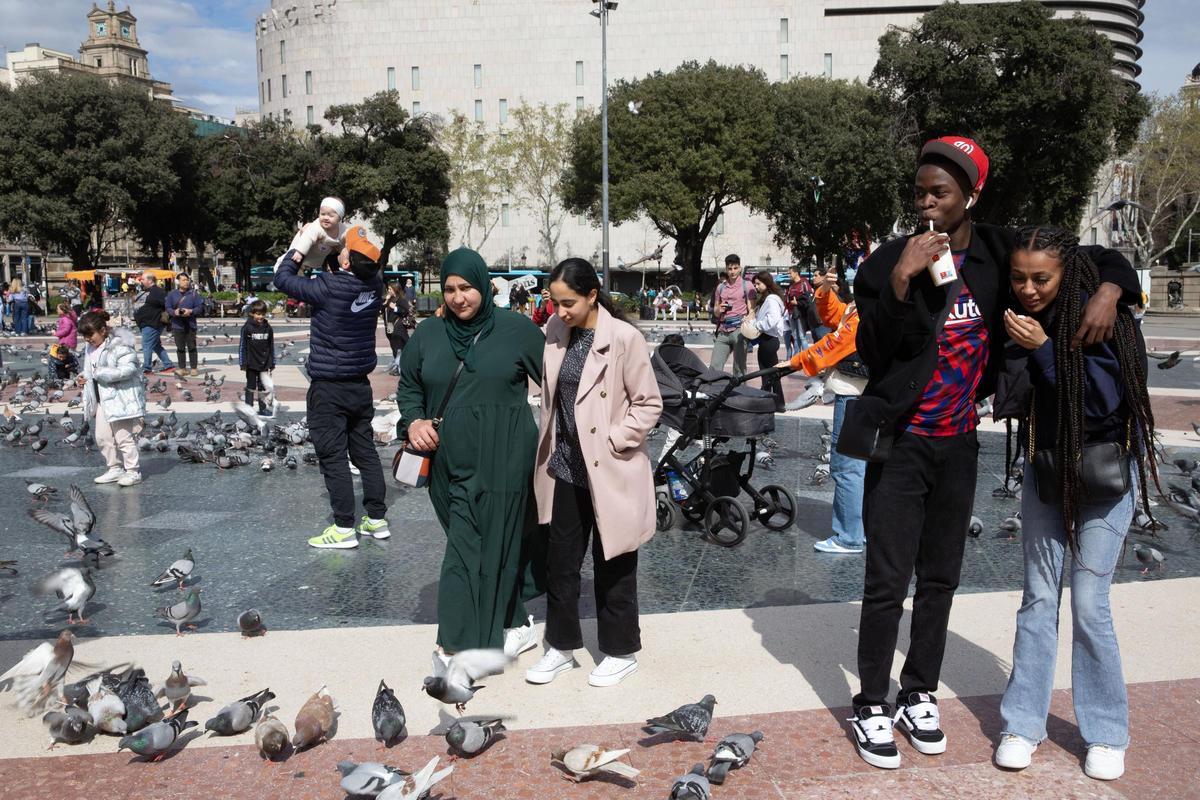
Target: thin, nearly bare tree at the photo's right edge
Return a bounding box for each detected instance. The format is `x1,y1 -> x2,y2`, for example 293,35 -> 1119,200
1118,95 -> 1200,266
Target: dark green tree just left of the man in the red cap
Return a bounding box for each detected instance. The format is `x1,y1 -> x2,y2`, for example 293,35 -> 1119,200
764,78 -> 911,278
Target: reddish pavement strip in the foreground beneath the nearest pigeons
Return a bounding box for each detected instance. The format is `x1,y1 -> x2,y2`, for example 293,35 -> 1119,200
0,679 -> 1200,800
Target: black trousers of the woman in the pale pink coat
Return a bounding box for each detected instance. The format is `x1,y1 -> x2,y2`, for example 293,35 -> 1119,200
545,480 -> 642,656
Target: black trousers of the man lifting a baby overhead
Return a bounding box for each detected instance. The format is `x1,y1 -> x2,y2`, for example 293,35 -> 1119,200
307,377 -> 388,528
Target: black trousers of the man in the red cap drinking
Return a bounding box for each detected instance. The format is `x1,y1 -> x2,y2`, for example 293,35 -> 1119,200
853,431 -> 979,708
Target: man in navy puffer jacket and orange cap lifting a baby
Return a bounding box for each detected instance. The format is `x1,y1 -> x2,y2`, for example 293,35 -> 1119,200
275,227 -> 391,549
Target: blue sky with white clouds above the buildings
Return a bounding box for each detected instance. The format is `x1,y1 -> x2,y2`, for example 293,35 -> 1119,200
0,0 -> 1200,119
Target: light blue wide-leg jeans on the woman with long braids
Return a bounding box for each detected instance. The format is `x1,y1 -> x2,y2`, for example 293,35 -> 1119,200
1000,468 -> 1138,750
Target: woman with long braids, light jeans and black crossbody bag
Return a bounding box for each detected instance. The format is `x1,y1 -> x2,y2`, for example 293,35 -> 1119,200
996,227 -> 1158,781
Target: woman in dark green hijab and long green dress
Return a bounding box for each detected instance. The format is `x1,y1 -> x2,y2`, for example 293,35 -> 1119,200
396,247 -> 545,656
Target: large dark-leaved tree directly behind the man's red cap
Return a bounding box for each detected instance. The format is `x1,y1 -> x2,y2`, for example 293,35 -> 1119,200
871,0 -> 1147,229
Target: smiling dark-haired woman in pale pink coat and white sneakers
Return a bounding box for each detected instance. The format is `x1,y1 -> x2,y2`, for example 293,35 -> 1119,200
526,258 -> 662,686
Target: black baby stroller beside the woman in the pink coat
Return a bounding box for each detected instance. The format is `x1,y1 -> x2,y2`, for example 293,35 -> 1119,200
650,335 -> 796,547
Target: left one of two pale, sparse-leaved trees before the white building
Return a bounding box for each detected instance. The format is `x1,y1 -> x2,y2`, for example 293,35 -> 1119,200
437,112 -> 512,249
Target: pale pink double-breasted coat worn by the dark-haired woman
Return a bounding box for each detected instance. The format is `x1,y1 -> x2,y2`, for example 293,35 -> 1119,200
533,307 -> 662,559
